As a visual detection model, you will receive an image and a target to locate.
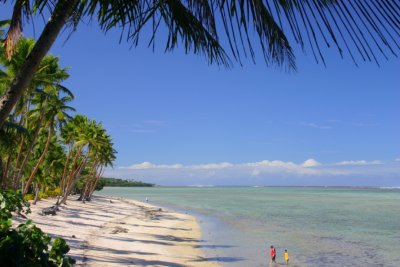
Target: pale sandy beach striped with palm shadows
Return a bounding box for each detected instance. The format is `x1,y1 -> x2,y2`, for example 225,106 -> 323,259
16,196 -> 219,267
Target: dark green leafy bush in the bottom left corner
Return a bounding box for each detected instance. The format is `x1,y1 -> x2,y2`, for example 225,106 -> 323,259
0,191 -> 75,267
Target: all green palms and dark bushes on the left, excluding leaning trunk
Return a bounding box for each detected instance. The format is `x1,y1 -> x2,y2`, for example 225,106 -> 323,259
0,24 -> 116,267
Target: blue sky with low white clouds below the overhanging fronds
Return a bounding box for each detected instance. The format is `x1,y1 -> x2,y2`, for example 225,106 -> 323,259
0,5 -> 400,186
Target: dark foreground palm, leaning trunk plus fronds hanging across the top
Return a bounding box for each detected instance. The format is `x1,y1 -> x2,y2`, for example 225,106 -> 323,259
0,0 -> 400,127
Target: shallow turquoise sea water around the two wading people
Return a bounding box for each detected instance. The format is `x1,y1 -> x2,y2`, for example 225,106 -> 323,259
99,187 -> 400,267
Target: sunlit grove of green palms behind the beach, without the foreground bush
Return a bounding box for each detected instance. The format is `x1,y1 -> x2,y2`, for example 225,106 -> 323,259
0,35 -> 116,203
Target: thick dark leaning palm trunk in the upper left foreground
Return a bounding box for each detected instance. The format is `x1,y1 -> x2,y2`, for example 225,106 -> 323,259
0,0 -> 78,128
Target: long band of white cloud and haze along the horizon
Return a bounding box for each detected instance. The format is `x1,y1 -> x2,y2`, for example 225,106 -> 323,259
105,158 -> 400,185
